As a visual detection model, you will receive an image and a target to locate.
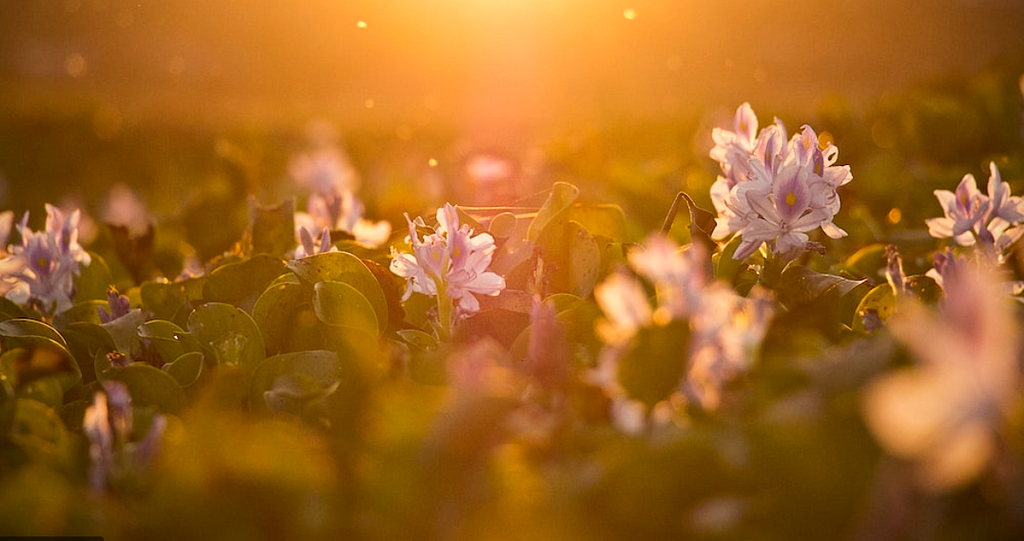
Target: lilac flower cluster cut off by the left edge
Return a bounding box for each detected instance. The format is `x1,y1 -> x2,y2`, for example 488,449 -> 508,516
0,205 -> 91,317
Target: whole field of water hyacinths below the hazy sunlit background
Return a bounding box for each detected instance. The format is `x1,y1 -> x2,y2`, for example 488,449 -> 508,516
0,3 -> 1024,541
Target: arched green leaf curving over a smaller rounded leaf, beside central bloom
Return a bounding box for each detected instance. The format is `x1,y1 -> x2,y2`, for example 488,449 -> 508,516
288,252 -> 388,332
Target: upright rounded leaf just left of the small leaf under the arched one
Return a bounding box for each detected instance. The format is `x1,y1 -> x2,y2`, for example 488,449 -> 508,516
253,275 -> 323,355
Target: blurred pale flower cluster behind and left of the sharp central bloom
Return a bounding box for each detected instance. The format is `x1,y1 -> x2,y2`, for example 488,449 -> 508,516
289,147 -> 391,252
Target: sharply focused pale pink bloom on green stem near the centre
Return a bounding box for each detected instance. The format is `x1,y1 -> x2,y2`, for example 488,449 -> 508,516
390,203 -> 505,333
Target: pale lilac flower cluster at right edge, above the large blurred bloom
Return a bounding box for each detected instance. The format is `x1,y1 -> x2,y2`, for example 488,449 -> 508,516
925,162 -> 1024,260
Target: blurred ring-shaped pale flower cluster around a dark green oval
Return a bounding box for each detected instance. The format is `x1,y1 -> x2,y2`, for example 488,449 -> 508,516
589,237 -> 771,430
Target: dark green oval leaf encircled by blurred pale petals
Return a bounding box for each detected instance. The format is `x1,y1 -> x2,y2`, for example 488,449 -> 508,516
618,321 -> 690,409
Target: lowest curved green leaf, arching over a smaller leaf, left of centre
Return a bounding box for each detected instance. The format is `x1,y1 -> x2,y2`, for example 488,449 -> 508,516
249,350 -> 341,412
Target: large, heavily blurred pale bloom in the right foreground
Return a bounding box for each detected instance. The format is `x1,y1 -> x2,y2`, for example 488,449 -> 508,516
863,259 -> 1021,492
